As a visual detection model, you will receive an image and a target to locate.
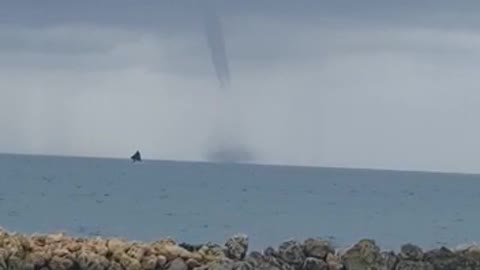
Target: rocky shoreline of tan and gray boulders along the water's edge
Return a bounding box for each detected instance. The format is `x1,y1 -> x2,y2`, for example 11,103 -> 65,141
0,230 -> 480,270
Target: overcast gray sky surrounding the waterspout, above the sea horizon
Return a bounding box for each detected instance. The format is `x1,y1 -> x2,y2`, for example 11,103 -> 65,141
0,0 -> 480,172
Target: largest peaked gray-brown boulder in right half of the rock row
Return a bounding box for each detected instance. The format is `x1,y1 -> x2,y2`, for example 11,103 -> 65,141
342,239 -> 387,270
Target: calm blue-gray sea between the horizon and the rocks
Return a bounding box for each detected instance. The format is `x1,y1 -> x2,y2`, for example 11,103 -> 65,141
0,155 -> 480,250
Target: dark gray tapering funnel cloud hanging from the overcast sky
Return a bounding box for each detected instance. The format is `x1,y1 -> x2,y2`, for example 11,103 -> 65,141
204,3 -> 230,89
